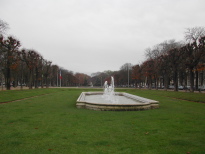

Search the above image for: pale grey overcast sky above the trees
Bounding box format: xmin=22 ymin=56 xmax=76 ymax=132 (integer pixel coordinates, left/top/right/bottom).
xmin=0 ymin=0 xmax=205 ymax=74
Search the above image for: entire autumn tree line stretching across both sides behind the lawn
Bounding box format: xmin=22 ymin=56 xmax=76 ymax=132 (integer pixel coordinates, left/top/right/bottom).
xmin=0 ymin=20 xmax=205 ymax=92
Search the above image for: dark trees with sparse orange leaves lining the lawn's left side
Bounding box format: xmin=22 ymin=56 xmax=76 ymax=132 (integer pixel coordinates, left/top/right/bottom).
xmin=0 ymin=20 xmax=89 ymax=90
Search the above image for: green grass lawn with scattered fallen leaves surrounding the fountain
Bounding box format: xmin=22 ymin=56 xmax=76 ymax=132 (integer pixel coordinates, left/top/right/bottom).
xmin=0 ymin=88 xmax=205 ymax=154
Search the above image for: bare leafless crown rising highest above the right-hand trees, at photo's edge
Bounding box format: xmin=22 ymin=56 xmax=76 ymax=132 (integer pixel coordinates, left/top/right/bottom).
xmin=184 ymin=27 xmax=205 ymax=43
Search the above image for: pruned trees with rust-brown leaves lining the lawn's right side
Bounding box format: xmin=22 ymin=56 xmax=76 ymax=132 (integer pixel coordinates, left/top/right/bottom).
xmin=132 ymin=37 xmax=205 ymax=92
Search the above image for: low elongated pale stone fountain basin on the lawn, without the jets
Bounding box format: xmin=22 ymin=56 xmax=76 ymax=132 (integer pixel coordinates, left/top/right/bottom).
xmin=76 ymin=92 xmax=159 ymax=111
